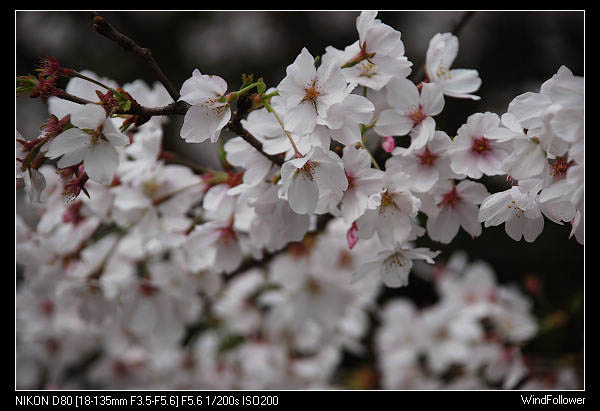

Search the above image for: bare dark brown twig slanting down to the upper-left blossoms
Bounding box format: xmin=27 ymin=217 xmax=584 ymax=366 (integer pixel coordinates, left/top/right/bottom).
xmin=92 ymin=12 xmax=180 ymax=101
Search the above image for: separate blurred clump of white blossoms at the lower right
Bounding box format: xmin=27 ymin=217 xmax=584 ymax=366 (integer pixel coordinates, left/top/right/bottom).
xmin=376 ymin=252 xmax=578 ymax=389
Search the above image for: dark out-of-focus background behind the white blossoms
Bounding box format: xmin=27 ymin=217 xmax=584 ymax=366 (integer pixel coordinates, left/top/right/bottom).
xmin=16 ymin=11 xmax=584 ymax=388
